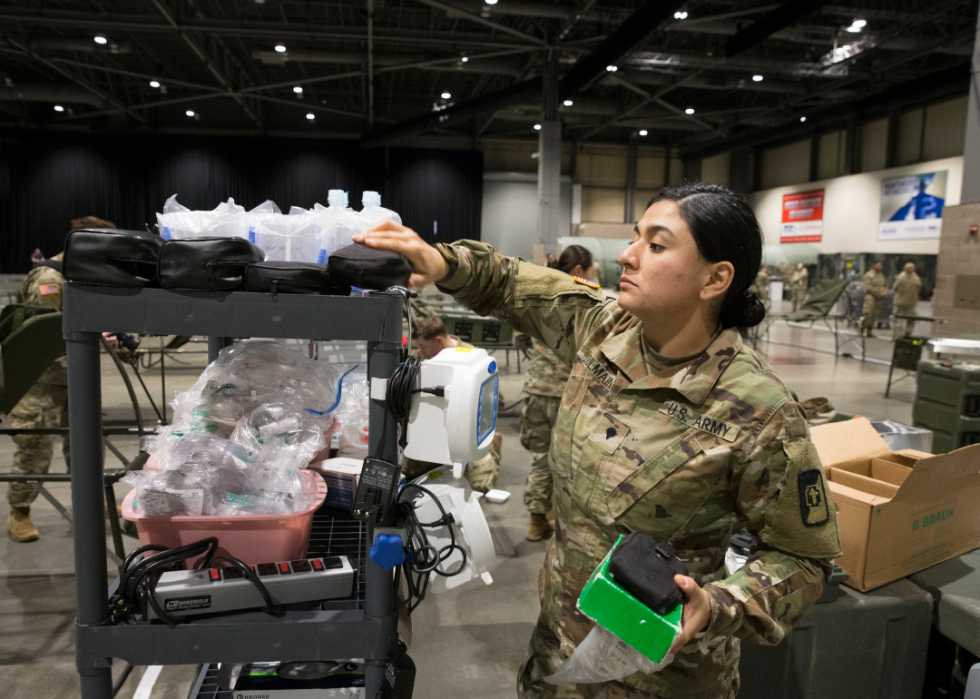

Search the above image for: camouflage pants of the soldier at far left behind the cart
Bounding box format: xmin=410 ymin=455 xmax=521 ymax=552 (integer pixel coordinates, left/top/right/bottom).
xmin=7 ymin=383 xmax=70 ymax=507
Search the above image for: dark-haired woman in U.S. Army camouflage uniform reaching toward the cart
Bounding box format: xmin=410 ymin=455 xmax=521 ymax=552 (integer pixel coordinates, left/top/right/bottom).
xmin=355 ymin=183 xmax=840 ymax=699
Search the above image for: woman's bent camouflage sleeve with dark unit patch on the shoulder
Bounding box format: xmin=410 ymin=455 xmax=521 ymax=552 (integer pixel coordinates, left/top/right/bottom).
xmin=704 ymin=402 xmax=840 ymax=644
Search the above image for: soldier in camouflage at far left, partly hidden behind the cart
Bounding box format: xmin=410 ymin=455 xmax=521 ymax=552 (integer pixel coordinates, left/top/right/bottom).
xmin=7 ymin=216 xmax=115 ymax=543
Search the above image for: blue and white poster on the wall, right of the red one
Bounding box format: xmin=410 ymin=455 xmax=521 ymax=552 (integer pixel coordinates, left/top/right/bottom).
xmin=878 ymin=170 xmax=948 ymax=240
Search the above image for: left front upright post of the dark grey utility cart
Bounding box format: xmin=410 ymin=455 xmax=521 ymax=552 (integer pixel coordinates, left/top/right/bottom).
xmin=65 ymin=333 xmax=112 ymax=699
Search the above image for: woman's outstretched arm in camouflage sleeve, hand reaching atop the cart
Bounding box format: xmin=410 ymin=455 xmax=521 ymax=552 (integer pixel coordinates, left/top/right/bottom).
xmin=354 ymin=221 xmax=612 ymax=363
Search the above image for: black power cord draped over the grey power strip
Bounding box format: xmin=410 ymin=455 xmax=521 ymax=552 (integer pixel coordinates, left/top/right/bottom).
xmin=109 ymin=536 xmax=281 ymax=627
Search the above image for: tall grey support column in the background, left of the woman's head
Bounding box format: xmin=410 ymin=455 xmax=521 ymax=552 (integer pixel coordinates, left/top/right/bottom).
xmin=538 ymin=50 xmax=568 ymax=253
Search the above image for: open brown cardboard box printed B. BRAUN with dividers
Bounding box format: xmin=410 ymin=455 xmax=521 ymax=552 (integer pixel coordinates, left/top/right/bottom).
xmin=810 ymin=418 xmax=980 ymax=592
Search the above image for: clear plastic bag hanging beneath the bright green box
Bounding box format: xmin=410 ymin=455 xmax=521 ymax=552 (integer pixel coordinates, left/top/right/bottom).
xmin=544 ymin=624 xmax=674 ymax=684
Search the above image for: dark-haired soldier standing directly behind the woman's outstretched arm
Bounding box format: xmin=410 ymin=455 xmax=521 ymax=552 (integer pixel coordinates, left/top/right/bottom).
xmin=521 ymin=245 xmax=595 ymax=541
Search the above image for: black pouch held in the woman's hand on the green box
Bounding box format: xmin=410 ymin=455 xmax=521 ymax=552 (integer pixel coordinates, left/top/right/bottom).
xmin=609 ymin=532 xmax=688 ymax=616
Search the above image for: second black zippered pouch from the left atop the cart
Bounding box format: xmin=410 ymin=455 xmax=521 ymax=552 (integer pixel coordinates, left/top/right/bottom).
xmin=157 ymin=238 xmax=265 ymax=291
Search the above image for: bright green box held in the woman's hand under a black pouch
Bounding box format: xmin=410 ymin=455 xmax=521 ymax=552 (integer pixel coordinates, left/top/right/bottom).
xmin=578 ymin=536 xmax=684 ymax=663
